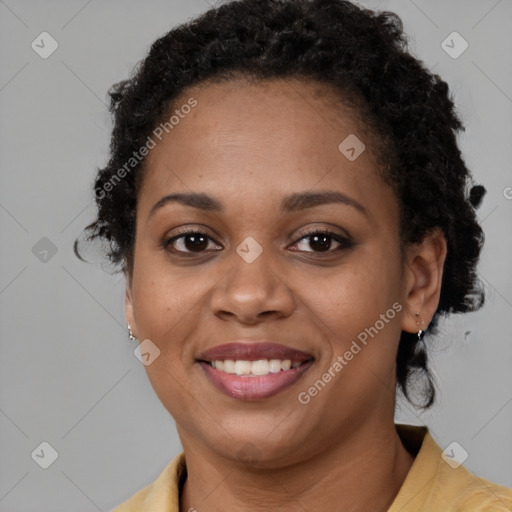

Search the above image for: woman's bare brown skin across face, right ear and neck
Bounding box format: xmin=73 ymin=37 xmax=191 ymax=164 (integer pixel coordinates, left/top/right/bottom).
xmin=126 ymin=79 xmax=446 ymax=512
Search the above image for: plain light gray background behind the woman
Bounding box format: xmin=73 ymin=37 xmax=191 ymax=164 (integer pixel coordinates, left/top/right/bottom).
xmin=0 ymin=0 xmax=512 ymax=512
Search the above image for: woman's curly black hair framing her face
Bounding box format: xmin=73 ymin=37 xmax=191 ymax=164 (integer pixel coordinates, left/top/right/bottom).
xmin=75 ymin=0 xmax=485 ymax=408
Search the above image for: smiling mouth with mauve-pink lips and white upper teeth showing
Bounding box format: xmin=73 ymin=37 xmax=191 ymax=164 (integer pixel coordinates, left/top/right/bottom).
xmin=196 ymin=341 xmax=314 ymax=400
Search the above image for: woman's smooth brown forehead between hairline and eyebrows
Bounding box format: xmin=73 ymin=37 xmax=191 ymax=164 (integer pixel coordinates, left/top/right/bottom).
xmin=135 ymin=79 xmax=392 ymax=222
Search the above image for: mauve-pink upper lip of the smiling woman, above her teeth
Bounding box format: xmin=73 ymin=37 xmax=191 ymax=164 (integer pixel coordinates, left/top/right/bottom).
xmin=197 ymin=340 xmax=313 ymax=363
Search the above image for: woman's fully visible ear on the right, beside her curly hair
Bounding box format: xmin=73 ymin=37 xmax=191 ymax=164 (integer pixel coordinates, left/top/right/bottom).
xmin=402 ymin=228 xmax=447 ymax=333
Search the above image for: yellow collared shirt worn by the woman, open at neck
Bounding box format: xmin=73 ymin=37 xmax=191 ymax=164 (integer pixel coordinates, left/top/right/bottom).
xmin=112 ymin=425 xmax=512 ymax=512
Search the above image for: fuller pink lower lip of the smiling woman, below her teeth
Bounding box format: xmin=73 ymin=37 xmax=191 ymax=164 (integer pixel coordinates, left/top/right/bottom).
xmin=199 ymin=360 xmax=313 ymax=400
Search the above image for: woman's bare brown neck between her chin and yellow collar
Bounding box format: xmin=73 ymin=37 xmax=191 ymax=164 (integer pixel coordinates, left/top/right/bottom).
xmin=180 ymin=423 xmax=414 ymax=512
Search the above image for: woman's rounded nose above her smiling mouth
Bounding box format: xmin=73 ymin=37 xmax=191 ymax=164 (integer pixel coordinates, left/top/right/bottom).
xmin=211 ymin=253 xmax=296 ymax=325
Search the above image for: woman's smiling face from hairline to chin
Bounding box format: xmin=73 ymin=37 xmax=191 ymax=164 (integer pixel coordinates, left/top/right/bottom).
xmin=126 ymin=79 xmax=440 ymax=465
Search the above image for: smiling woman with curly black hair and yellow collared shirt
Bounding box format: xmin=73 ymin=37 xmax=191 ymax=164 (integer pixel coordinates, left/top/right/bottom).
xmin=77 ymin=0 xmax=512 ymax=512
